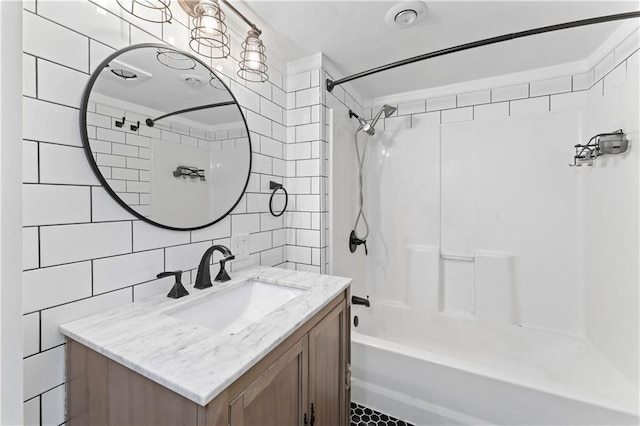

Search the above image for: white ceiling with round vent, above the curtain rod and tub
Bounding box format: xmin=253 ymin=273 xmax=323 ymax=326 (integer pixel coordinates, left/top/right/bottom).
xmin=242 ymin=0 xmax=640 ymax=99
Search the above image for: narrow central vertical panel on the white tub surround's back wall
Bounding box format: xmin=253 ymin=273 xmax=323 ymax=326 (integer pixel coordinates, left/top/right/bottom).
xmin=442 ymin=123 xmax=481 ymax=257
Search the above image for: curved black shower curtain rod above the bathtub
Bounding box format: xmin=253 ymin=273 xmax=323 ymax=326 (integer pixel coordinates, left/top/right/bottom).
xmin=326 ymin=12 xmax=640 ymax=92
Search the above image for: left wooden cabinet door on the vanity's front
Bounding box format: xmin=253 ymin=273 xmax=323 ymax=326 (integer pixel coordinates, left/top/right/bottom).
xmin=229 ymin=336 xmax=308 ymax=426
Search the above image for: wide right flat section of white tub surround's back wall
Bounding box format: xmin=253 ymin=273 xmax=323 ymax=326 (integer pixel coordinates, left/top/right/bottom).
xmin=474 ymin=110 xmax=584 ymax=334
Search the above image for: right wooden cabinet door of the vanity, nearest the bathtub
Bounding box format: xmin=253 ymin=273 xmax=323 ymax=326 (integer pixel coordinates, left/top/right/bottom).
xmin=309 ymin=302 xmax=348 ymax=426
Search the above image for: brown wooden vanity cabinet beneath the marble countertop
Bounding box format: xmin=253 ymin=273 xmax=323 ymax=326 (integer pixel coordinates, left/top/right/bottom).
xmin=67 ymin=289 xmax=350 ymax=426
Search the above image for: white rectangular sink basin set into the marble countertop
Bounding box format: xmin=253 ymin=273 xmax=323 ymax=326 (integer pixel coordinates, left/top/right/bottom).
xmin=166 ymin=279 xmax=305 ymax=334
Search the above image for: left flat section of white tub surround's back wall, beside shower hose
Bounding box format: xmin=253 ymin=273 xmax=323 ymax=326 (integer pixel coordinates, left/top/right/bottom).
xmin=364 ymin=127 xmax=440 ymax=304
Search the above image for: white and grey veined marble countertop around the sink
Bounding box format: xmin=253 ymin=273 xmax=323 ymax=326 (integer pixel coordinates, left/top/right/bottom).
xmin=60 ymin=265 xmax=351 ymax=406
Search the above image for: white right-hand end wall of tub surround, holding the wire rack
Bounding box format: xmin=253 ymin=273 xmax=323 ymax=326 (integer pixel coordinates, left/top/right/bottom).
xmin=578 ymin=51 xmax=640 ymax=387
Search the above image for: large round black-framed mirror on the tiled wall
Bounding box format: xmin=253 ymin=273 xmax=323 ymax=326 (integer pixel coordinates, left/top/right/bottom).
xmin=80 ymin=44 xmax=252 ymax=230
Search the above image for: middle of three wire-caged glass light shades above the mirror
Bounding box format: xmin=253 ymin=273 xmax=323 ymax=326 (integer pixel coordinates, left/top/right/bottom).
xmin=189 ymin=0 xmax=231 ymax=58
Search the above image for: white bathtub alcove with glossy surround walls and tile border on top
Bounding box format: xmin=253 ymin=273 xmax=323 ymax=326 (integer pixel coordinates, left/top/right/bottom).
xmin=327 ymin=23 xmax=640 ymax=425
